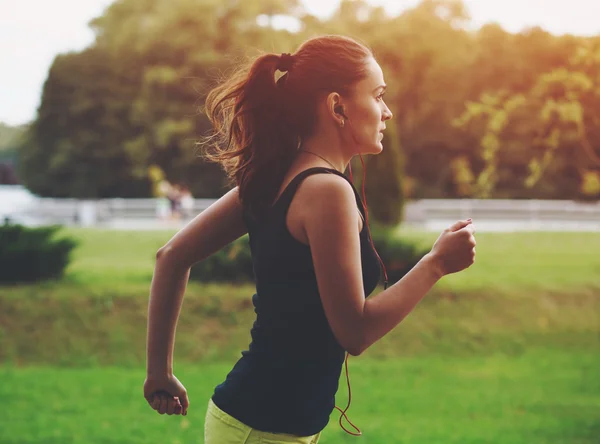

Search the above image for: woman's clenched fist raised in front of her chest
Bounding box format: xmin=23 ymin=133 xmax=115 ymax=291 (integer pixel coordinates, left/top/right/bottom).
xmin=430 ymin=219 xmax=476 ymax=276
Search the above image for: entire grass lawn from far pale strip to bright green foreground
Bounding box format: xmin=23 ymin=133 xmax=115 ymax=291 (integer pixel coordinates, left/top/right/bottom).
xmin=0 ymin=230 xmax=600 ymax=444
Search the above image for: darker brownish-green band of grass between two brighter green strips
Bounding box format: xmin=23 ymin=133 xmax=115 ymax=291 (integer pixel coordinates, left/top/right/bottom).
xmin=0 ymin=278 xmax=600 ymax=367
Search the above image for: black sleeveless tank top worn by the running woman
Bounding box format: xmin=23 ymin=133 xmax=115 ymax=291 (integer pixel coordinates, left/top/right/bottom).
xmin=212 ymin=168 xmax=381 ymax=436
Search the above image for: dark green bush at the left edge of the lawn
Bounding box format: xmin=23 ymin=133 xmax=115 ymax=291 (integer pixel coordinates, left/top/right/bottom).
xmin=0 ymin=223 xmax=77 ymax=284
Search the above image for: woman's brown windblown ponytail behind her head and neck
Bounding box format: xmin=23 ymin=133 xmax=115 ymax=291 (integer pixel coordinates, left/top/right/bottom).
xmin=205 ymin=54 xmax=299 ymax=214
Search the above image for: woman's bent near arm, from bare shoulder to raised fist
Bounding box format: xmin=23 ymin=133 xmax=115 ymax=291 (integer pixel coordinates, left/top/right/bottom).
xmin=299 ymin=176 xmax=474 ymax=355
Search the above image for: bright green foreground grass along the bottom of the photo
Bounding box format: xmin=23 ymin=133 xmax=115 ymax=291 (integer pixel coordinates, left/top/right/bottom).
xmin=0 ymin=349 xmax=600 ymax=444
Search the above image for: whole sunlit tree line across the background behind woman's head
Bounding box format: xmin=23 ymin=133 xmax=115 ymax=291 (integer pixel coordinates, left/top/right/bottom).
xmin=4 ymin=0 xmax=600 ymax=215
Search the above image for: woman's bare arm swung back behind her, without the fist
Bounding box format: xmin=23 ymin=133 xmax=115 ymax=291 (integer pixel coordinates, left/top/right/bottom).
xmin=146 ymin=188 xmax=247 ymax=376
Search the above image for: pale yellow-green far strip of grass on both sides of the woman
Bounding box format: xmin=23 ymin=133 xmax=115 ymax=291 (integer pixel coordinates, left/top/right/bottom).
xmin=52 ymin=229 xmax=600 ymax=292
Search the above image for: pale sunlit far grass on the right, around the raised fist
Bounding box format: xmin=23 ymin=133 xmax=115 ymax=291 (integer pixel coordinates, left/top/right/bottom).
xmin=398 ymin=230 xmax=600 ymax=292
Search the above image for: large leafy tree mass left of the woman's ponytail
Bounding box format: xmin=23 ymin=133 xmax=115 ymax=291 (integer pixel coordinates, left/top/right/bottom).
xmin=21 ymin=0 xmax=310 ymax=198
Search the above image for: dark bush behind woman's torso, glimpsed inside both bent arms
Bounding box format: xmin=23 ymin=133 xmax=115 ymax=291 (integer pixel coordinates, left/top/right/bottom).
xmin=190 ymin=228 xmax=426 ymax=285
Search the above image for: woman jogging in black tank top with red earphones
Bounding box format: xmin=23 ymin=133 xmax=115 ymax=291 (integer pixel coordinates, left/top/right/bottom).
xmin=144 ymin=36 xmax=475 ymax=444
